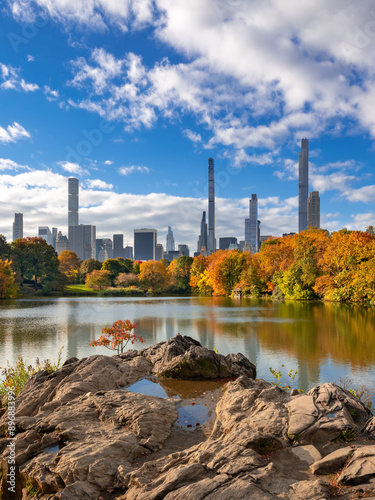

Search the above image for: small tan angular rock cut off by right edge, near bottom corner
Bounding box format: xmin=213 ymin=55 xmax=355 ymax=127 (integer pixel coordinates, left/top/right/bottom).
xmin=337 ymin=445 xmax=375 ymax=485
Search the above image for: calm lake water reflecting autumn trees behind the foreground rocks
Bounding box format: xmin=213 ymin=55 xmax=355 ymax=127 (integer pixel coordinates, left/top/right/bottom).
xmin=0 ymin=297 xmax=375 ymax=390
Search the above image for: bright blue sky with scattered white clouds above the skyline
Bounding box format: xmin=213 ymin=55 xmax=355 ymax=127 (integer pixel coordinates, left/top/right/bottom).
xmin=0 ymin=0 xmax=375 ymax=252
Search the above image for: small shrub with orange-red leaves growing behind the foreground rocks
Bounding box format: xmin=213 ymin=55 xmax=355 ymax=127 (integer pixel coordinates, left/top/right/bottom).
xmin=89 ymin=319 xmax=144 ymax=354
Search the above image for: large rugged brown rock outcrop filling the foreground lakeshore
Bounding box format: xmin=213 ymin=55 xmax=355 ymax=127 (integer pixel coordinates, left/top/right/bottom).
xmin=0 ymin=335 xmax=375 ymax=500
